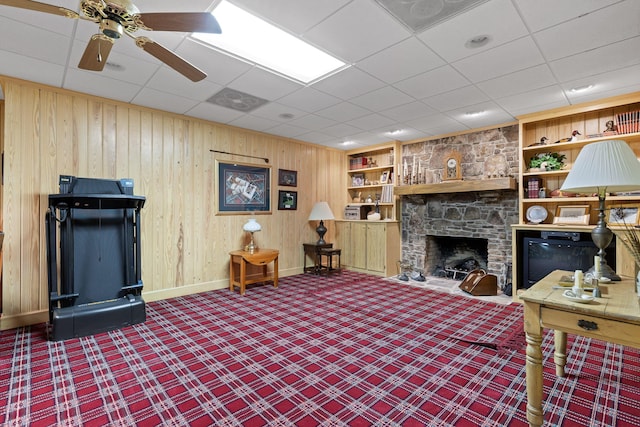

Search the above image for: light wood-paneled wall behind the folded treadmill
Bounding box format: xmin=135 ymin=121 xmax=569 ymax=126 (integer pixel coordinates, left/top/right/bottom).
xmin=0 ymin=78 xmax=347 ymax=329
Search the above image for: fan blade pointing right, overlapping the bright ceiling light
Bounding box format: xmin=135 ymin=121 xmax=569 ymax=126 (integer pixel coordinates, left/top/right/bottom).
xmin=135 ymin=12 xmax=222 ymax=34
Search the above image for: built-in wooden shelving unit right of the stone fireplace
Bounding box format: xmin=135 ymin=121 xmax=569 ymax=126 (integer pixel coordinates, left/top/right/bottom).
xmin=513 ymin=92 xmax=640 ymax=300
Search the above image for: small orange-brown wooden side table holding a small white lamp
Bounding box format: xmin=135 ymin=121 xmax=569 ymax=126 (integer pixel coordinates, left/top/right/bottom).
xmin=229 ymin=249 xmax=280 ymax=295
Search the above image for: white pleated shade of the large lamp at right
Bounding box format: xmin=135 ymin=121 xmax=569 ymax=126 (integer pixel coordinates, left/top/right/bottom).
xmin=561 ymin=140 xmax=640 ymax=194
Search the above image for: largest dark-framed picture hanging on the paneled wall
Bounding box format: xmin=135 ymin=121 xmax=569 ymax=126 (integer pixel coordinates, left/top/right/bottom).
xmin=216 ymin=160 xmax=271 ymax=215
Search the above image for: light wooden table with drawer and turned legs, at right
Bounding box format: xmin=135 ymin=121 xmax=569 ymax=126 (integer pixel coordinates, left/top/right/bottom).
xmin=520 ymin=270 xmax=640 ymax=426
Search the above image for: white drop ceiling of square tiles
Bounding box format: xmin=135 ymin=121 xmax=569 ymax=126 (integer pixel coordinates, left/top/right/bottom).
xmin=0 ymin=0 xmax=640 ymax=149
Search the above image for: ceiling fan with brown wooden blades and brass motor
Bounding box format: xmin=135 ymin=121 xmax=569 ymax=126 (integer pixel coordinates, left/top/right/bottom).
xmin=0 ymin=0 xmax=222 ymax=82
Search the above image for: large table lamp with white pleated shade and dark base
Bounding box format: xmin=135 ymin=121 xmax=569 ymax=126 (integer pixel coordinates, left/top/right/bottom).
xmin=560 ymin=140 xmax=640 ymax=280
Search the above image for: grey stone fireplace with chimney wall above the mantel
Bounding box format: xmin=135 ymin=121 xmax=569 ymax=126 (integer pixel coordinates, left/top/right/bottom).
xmin=400 ymin=125 xmax=518 ymax=287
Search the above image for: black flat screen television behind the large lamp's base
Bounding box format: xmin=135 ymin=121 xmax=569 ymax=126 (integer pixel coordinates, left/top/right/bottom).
xmin=520 ymin=233 xmax=616 ymax=288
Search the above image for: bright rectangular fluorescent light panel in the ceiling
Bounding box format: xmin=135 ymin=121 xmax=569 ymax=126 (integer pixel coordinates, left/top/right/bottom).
xmin=193 ymin=1 xmax=347 ymax=84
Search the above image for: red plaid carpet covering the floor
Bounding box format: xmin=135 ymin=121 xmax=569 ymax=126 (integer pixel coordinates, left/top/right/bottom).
xmin=0 ymin=272 xmax=640 ymax=426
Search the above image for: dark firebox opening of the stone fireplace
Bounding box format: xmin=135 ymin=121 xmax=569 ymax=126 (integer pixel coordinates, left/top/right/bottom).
xmin=424 ymin=236 xmax=489 ymax=280
